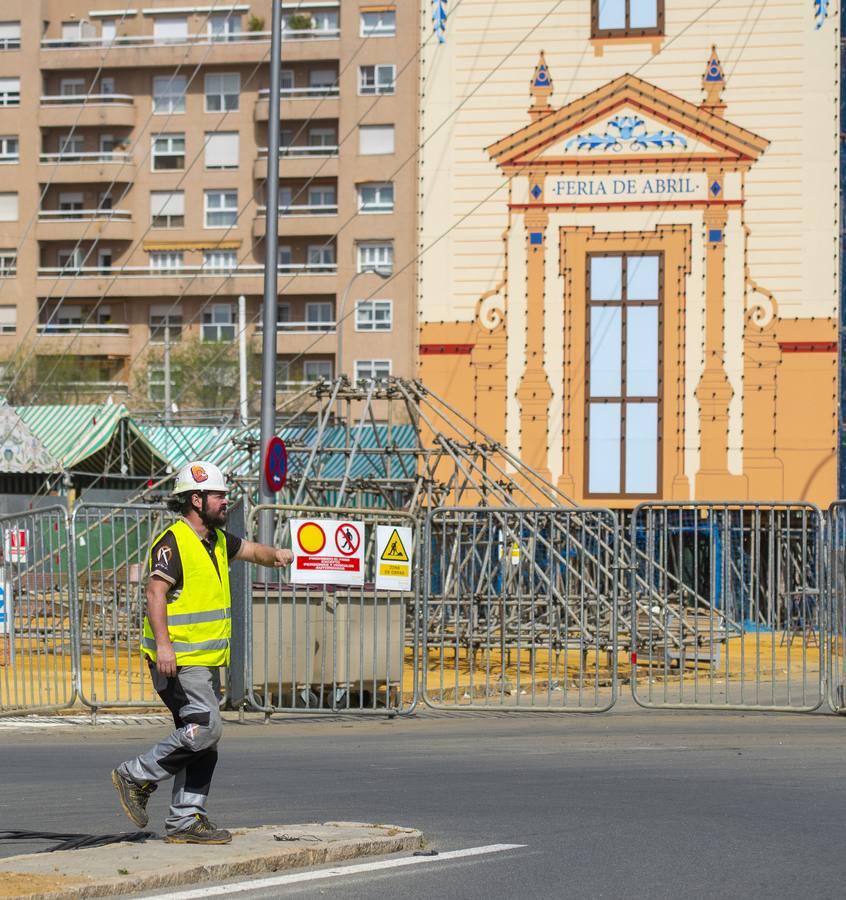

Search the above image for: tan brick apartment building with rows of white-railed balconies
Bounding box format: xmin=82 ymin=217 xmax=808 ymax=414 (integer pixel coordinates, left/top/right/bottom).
xmin=0 ymin=0 xmax=418 ymax=407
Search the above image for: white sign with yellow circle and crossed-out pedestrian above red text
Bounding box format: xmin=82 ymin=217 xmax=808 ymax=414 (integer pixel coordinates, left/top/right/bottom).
xmin=291 ymin=519 xmax=364 ymax=585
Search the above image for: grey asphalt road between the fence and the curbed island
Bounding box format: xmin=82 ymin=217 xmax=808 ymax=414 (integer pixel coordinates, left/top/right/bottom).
xmin=0 ymin=704 xmax=846 ymax=900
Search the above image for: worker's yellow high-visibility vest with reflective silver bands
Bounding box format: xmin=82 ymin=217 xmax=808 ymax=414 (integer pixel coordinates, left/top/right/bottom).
xmin=141 ymin=519 xmax=232 ymax=666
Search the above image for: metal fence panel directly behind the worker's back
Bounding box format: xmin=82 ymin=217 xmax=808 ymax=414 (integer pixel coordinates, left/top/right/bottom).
xmin=71 ymin=503 xmax=172 ymax=708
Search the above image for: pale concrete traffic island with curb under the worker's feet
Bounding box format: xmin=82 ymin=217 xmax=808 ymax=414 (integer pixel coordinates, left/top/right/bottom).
xmin=0 ymin=822 xmax=423 ymax=900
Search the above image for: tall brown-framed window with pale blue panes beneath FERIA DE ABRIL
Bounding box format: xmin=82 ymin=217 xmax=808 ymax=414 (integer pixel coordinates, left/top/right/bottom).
xmin=585 ymin=253 xmax=662 ymax=496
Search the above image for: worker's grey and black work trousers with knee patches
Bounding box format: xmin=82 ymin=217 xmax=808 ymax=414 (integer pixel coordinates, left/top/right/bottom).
xmin=118 ymin=663 xmax=223 ymax=834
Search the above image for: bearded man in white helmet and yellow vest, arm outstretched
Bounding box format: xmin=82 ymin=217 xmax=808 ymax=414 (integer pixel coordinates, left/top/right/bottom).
xmin=112 ymin=460 xmax=293 ymax=844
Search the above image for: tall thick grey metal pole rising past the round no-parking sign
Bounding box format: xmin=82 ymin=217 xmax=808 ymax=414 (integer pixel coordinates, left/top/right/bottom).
xmin=259 ymin=0 xmax=282 ymax=544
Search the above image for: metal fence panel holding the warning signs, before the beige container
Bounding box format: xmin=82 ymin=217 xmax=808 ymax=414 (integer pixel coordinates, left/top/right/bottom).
xmin=246 ymin=506 xmax=420 ymax=715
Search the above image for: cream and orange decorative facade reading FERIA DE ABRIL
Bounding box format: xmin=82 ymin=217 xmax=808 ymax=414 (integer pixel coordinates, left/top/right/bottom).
xmin=419 ymin=0 xmax=839 ymax=507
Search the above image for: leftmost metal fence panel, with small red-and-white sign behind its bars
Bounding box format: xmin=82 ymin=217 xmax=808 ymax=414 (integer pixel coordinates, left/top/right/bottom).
xmin=0 ymin=506 xmax=76 ymax=713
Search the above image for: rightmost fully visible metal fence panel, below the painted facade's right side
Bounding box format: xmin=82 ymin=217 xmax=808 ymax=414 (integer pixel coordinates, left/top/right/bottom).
xmin=629 ymin=503 xmax=825 ymax=711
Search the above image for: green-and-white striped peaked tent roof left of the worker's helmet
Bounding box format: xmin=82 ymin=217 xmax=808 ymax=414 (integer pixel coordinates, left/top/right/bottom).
xmin=16 ymin=403 xmax=167 ymax=477
